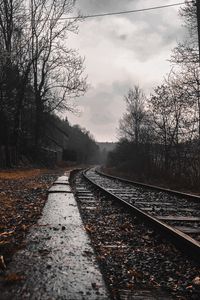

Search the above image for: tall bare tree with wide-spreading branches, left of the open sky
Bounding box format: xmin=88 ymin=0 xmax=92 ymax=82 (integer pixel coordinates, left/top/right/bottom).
xmin=30 ymin=0 xmax=86 ymax=145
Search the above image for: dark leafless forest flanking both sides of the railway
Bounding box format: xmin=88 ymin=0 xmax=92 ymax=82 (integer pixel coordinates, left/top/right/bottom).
xmin=0 ymin=0 xmax=200 ymax=187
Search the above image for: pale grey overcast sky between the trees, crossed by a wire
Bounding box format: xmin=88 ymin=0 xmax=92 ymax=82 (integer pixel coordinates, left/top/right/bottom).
xmin=67 ymin=0 xmax=184 ymax=141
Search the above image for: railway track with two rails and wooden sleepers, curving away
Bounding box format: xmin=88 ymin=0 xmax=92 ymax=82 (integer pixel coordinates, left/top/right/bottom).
xmin=81 ymin=168 xmax=200 ymax=260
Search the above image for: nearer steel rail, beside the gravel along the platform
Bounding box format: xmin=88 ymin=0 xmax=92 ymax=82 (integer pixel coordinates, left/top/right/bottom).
xmin=83 ymin=169 xmax=200 ymax=262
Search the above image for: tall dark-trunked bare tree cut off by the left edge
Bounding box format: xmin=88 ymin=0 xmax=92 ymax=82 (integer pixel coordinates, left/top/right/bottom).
xmin=0 ymin=0 xmax=30 ymax=162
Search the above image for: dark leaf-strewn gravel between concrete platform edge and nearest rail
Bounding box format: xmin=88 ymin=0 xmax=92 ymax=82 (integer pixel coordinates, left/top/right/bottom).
xmin=73 ymin=174 xmax=200 ymax=300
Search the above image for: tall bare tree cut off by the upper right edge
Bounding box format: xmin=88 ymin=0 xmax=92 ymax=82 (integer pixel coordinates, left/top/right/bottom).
xmin=171 ymin=1 xmax=200 ymax=140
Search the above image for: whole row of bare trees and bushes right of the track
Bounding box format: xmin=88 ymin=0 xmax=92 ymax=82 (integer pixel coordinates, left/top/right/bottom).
xmin=108 ymin=1 xmax=200 ymax=186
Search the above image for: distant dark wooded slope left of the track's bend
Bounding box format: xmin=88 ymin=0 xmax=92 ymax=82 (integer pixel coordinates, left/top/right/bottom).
xmin=44 ymin=114 xmax=100 ymax=164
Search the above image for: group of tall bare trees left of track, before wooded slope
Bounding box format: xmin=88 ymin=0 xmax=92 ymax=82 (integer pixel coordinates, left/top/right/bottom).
xmin=0 ymin=0 xmax=87 ymax=166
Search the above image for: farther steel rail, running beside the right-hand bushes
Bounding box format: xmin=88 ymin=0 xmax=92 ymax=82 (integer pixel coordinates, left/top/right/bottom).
xmin=95 ymin=168 xmax=200 ymax=203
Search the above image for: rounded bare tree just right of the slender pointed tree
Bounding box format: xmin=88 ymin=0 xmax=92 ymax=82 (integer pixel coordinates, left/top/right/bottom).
xmin=149 ymin=72 xmax=193 ymax=171
